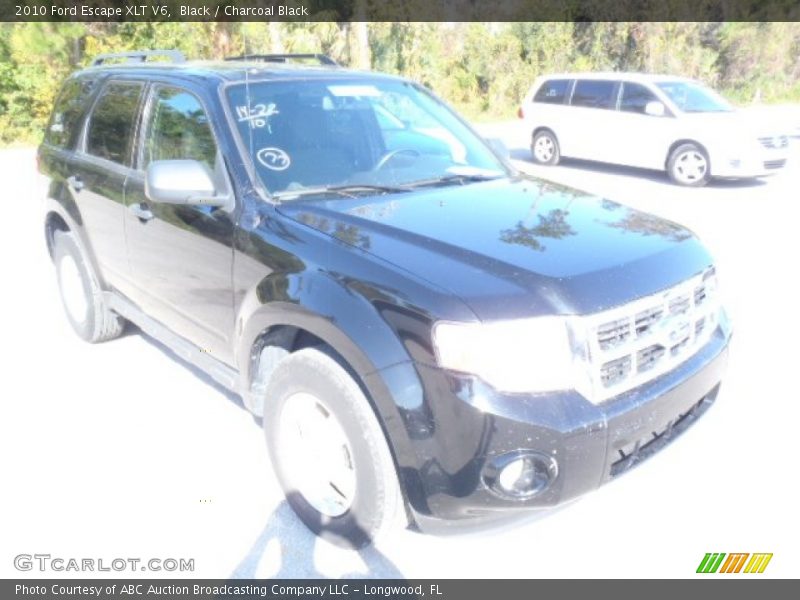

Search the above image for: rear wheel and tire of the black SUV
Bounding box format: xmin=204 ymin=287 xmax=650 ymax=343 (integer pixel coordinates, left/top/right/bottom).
xmin=53 ymin=231 xmax=125 ymax=343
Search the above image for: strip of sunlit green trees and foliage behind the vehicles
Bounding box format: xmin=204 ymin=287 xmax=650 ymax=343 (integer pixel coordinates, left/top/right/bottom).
xmin=0 ymin=22 xmax=800 ymax=144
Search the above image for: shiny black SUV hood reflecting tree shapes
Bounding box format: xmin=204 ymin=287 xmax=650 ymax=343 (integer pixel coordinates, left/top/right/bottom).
xmin=278 ymin=179 xmax=711 ymax=320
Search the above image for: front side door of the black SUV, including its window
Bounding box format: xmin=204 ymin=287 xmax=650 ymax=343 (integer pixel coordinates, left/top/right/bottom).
xmin=125 ymin=84 xmax=234 ymax=364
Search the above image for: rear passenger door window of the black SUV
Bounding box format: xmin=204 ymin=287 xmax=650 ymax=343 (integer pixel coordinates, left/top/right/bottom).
xmin=86 ymin=81 xmax=143 ymax=165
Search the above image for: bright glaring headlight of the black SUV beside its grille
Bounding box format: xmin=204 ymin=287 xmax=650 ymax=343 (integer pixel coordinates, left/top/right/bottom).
xmin=433 ymin=317 xmax=577 ymax=393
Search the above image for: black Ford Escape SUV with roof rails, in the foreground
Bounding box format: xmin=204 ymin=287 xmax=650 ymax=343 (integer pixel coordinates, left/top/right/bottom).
xmin=39 ymin=52 xmax=730 ymax=546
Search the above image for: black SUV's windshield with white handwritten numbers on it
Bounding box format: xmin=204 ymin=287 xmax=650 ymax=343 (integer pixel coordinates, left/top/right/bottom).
xmin=227 ymin=79 xmax=509 ymax=200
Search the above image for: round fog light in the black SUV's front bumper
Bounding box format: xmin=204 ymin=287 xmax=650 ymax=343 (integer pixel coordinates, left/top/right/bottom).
xmin=483 ymin=450 xmax=558 ymax=500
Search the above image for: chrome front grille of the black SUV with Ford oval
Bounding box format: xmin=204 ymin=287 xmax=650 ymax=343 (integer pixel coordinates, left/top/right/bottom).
xmin=584 ymin=267 xmax=719 ymax=402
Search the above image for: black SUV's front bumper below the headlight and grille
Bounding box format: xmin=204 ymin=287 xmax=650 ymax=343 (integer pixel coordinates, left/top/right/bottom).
xmin=368 ymin=327 xmax=729 ymax=533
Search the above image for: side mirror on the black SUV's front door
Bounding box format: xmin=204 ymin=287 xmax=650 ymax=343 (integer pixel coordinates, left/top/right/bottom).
xmin=144 ymin=160 xmax=229 ymax=206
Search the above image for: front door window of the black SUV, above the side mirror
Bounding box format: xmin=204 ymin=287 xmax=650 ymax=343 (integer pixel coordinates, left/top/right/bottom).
xmin=142 ymin=87 xmax=217 ymax=171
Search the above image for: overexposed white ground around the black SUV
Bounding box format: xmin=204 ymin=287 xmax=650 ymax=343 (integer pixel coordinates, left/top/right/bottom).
xmin=0 ymin=117 xmax=800 ymax=578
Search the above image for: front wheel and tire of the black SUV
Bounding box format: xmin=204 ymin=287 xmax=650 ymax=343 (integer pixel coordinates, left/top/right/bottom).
xmin=263 ymin=347 xmax=405 ymax=548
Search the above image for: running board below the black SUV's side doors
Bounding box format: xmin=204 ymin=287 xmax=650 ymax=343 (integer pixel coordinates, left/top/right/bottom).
xmin=103 ymin=292 xmax=244 ymax=399
